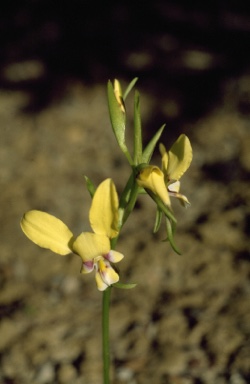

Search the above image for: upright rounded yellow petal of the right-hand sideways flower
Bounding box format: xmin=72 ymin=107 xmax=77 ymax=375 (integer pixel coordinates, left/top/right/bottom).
xmin=164 ymin=134 xmax=193 ymax=180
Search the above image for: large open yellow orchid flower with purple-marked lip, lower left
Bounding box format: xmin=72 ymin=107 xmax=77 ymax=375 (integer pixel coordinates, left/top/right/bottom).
xmin=21 ymin=179 xmax=124 ymax=291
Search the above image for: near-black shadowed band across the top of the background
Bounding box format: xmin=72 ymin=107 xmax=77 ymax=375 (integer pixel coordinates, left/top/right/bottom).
xmin=0 ymin=0 xmax=250 ymax=126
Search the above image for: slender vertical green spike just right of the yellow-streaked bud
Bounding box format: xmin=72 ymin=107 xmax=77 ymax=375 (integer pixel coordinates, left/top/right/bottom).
xmin=134 ymin=91 xmax=142 ymax=165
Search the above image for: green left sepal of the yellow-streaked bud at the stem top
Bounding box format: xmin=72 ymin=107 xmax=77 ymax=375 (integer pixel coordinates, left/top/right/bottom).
xmin=108 ymin=80 xmax=133 ymax=165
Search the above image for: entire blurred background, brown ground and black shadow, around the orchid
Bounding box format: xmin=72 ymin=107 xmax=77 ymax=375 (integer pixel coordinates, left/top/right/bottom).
xmin=0 ymin=0 xmax=250 ymax=384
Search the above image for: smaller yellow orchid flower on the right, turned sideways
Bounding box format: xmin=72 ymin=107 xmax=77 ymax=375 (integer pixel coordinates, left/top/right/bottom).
xmin=137 ymin=134 xmax=193 ymax=206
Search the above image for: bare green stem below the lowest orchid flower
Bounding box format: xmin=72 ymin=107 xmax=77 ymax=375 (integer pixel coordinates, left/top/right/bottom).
xmin=102 ymin=287 xmax=111 ymax=384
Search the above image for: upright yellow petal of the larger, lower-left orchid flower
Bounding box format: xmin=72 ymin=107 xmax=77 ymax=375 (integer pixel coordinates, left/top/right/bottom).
xmin=89 ymin=179 xmax=119 ymax=239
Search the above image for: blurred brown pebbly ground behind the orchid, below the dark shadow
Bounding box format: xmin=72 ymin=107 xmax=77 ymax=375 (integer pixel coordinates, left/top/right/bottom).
xmin=0 ymin=67 xmax=250 ymax=384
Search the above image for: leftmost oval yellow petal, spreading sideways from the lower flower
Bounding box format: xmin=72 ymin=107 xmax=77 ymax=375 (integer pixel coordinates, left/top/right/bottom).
xmin=21 ymin=210 xmax=73 ymax=255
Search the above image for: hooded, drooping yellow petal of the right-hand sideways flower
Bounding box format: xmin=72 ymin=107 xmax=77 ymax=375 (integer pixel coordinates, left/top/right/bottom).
xmin=136 ymin=165 xmax=170 ymax=206
